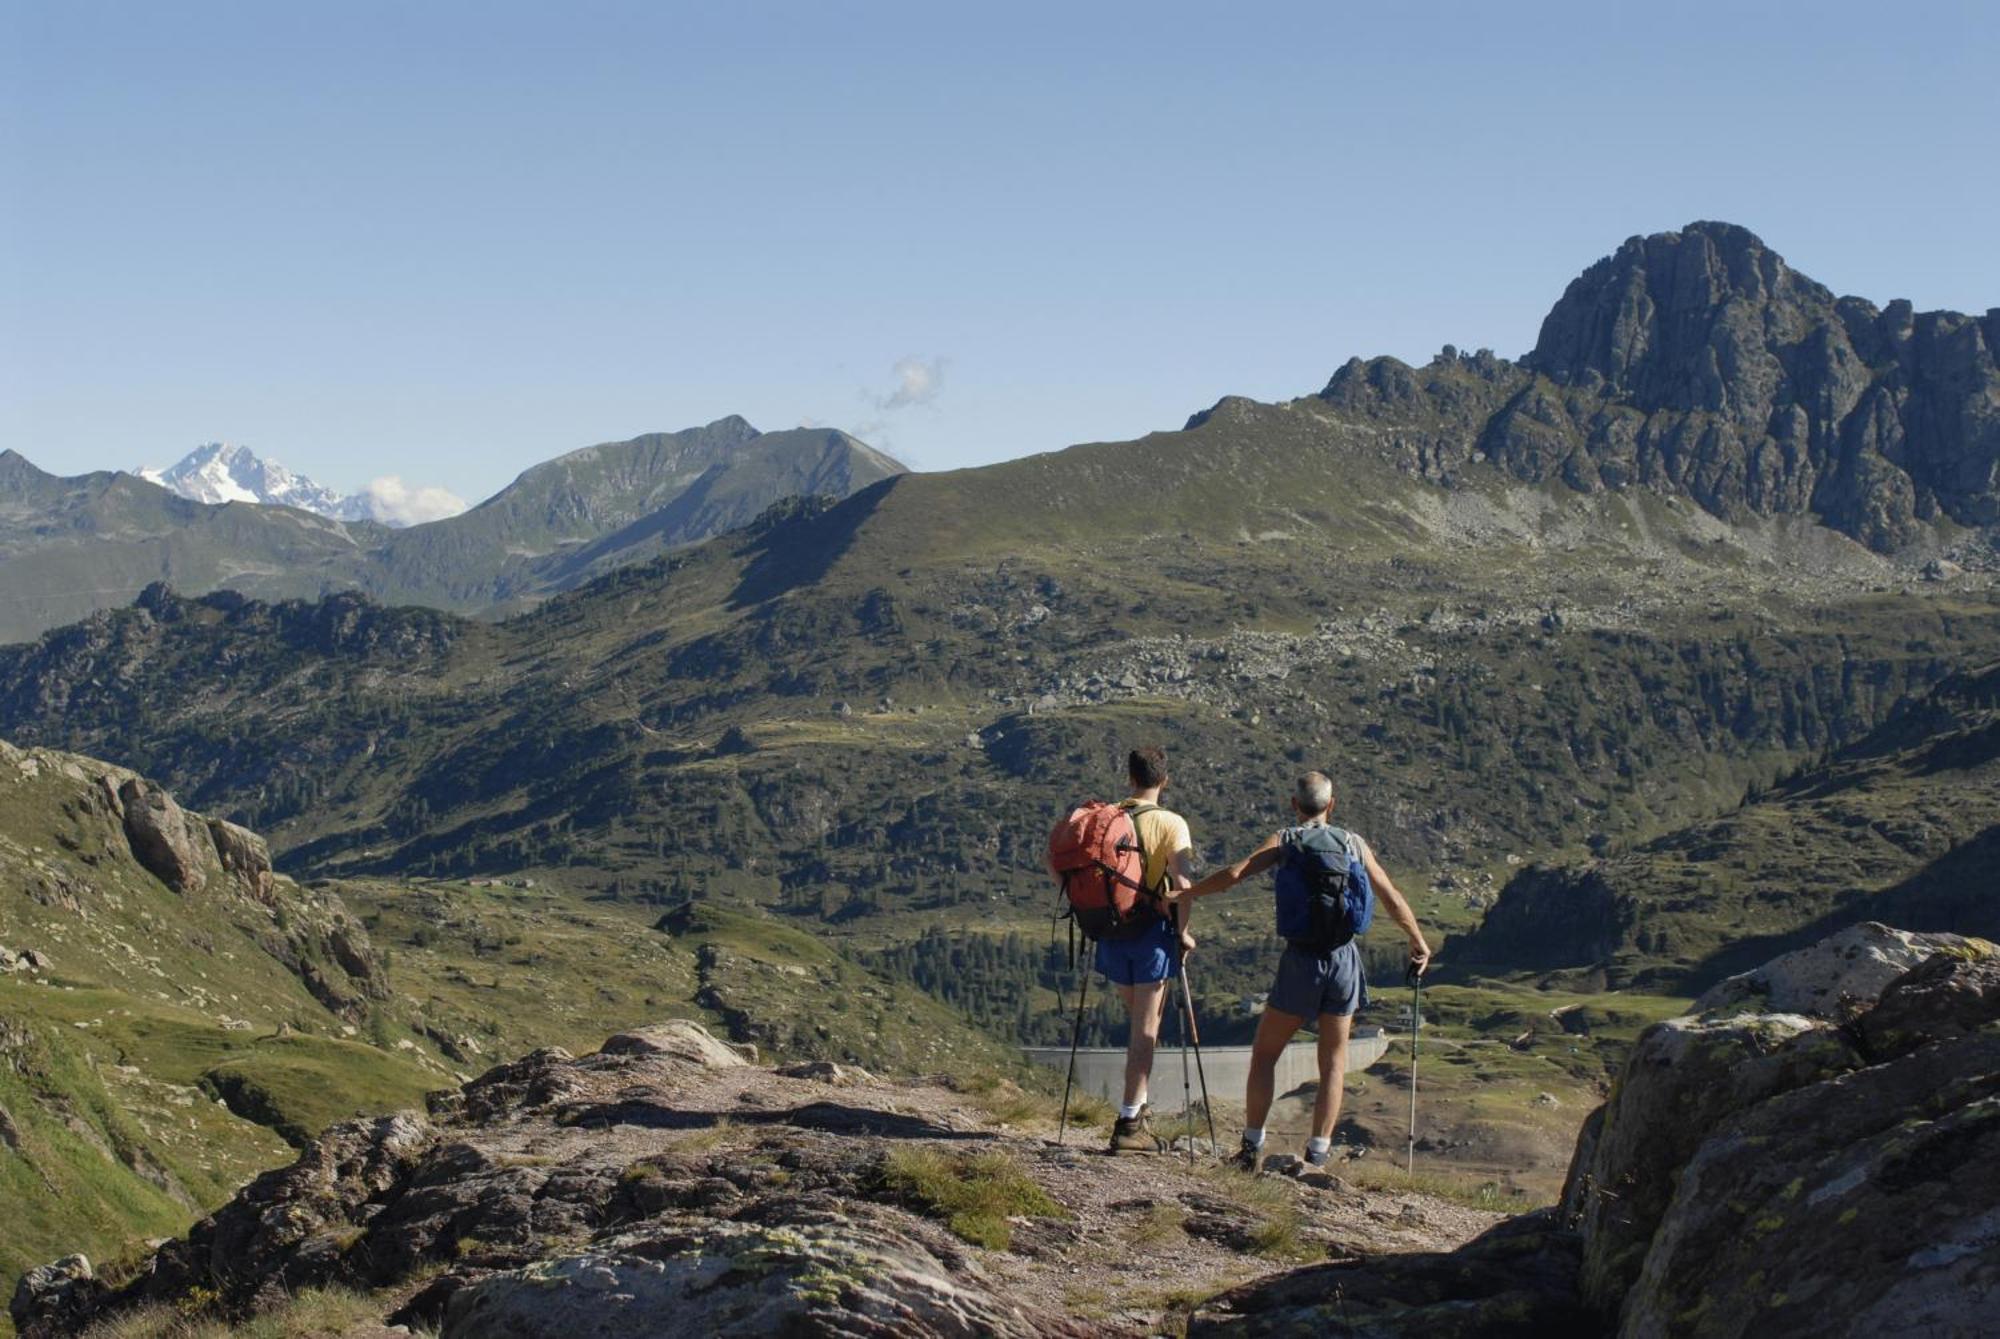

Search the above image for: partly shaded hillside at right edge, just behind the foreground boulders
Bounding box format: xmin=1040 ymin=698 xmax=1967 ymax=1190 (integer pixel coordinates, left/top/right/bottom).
xmin=1460 ymin=666 xmax=2000 ymax=989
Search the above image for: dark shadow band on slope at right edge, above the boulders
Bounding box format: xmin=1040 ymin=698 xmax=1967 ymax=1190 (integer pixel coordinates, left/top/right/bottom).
xmin=1692 ymin=825 xmax=2000 ymax=989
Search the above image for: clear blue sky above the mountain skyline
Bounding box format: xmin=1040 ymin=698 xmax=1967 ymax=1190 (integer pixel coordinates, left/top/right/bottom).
xmin=0 ymin=0 xmax=2000 ymax=498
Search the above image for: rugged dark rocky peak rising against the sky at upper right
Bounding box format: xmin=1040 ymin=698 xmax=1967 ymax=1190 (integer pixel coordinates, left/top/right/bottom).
xmin=1520 ymin=224 xmax=2000 ymax=548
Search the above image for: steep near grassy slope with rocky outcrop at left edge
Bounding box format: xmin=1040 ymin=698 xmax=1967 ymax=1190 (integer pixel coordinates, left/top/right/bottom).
xmin=0 ymin=743 xmax=448 ymax=1277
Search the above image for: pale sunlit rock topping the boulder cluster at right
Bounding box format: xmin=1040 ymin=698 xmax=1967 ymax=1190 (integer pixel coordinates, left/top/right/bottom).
xmin=1694 ymin=921 xmax=1980 ymax=1021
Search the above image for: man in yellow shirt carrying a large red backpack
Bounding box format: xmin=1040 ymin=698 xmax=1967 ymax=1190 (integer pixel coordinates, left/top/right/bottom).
xmin=1048 ymin=747 xmax=1194 ymax=1153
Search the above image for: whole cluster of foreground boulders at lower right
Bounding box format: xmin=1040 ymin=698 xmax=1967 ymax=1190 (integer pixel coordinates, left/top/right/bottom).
xmin=1564 ymin=925 xmax=2000 ymax=1339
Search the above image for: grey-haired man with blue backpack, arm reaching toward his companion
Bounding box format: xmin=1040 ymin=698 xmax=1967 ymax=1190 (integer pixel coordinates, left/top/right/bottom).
xmin=1170 ymin=771 xmax=1430 ymax=1171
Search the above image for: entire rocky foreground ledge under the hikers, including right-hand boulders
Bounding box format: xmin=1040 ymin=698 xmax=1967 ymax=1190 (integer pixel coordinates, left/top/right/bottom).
xmin=14 ymin=925 xmax=2000 ymax=1339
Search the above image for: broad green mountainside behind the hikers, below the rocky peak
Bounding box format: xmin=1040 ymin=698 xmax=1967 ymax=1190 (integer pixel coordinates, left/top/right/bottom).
xmin=0 ymin=429 xmax=2000 ymax=1039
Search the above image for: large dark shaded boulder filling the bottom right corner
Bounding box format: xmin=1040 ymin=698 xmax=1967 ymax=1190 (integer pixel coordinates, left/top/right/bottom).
xmin=1620 ymin=1033 xmax=2000 ymax=1339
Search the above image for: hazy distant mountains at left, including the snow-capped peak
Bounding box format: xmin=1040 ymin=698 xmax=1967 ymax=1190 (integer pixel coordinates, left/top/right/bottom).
xmin=0 ymin=416 xmax=902 ymax=642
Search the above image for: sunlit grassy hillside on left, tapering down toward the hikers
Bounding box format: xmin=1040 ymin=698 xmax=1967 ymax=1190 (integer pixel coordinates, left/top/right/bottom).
xmin=0 ymin=743 xmax=1018 ymax=1285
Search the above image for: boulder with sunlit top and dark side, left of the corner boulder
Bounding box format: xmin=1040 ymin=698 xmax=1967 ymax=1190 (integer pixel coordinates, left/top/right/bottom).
xmin=1564 ymin=1013 xmax=1862 ymax=1315
